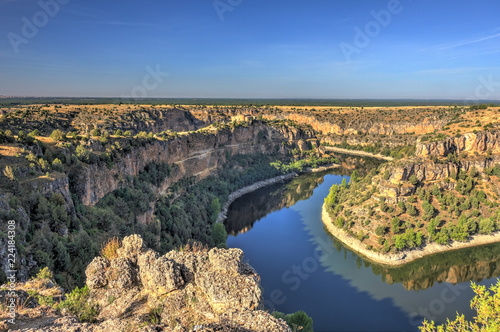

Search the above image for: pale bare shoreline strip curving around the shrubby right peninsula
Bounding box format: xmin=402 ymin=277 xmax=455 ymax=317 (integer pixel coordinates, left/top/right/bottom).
xmin=321 ymin=204 xmax=500 ymax=266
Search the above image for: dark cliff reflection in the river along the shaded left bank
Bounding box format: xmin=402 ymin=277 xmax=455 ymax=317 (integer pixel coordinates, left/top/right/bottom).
xmin=224 ymin=155 xmax=380 ymax=235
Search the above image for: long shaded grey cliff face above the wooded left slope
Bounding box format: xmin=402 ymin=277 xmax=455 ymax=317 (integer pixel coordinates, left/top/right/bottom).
xmin=74 ymin=123 xmax=310 ymax=205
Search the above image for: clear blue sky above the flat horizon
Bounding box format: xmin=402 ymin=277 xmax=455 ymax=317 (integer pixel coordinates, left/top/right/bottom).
xmin=0 ymin=0 xmax=500 ymax=100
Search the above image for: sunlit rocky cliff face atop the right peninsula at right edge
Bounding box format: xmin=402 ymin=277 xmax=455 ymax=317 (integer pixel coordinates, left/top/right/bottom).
xmin=415 ymin=131 xmax=500 ymax=158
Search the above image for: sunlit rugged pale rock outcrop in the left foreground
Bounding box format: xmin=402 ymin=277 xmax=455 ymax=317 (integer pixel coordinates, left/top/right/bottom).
xmin=0 ymin=235 xmax=291 ymax=332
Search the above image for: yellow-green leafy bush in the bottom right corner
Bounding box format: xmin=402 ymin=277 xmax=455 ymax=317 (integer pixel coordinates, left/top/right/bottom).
xmin=419 ymin=280 xmax=500 ymax=332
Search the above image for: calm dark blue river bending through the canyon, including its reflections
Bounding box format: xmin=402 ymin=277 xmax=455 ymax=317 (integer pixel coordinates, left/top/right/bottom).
xmin=225 ymin=166 xmax=500 ymax=332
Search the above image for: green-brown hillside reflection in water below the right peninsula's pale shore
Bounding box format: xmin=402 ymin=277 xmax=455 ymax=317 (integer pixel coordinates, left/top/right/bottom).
xmin=328 ymin=233 xmax=500 ymax=291
